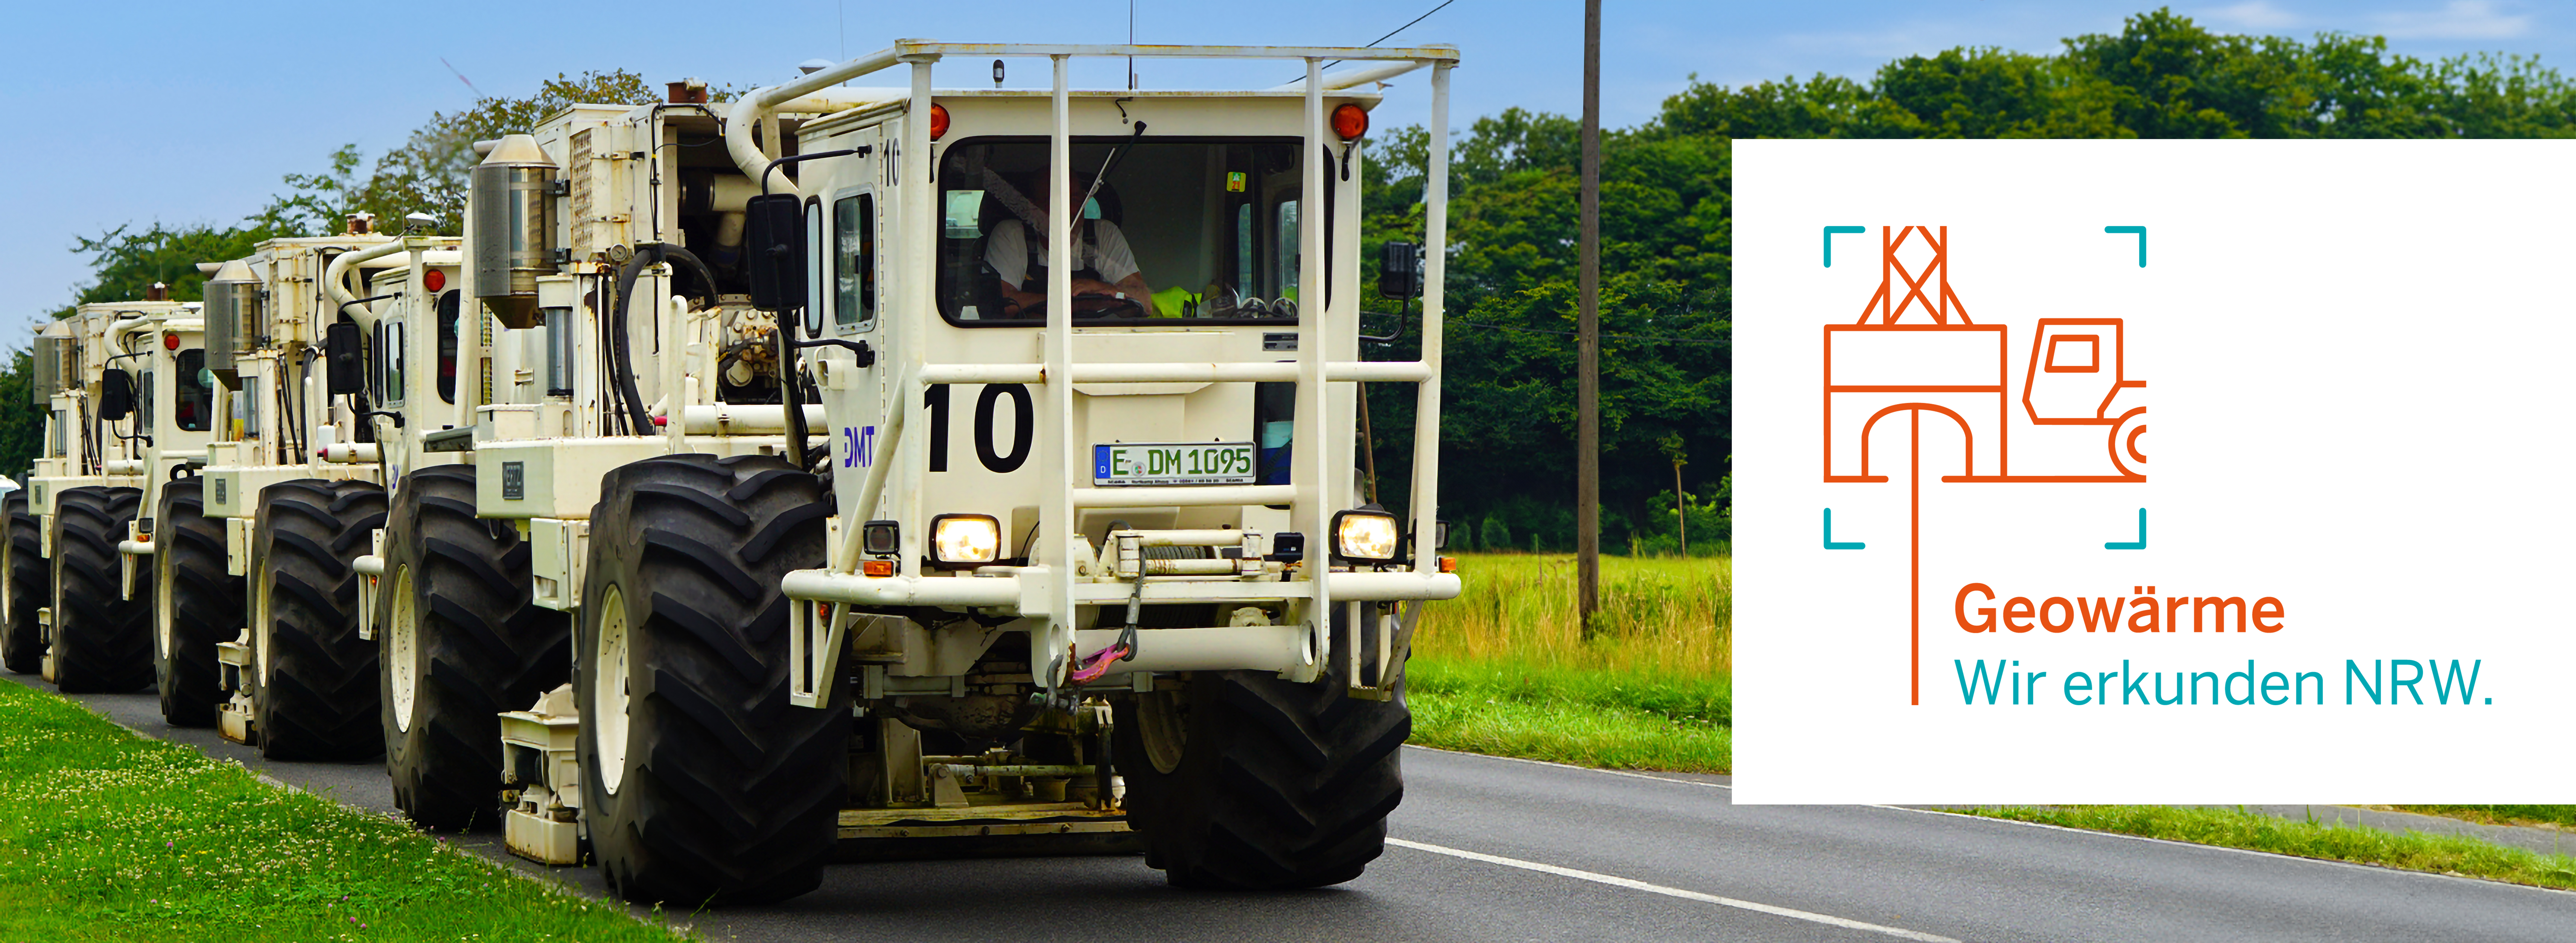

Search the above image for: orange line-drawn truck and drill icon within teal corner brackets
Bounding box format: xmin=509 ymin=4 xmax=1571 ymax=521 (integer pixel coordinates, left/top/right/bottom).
xmin=1824 ymin=227 xmax=2146 ymax=703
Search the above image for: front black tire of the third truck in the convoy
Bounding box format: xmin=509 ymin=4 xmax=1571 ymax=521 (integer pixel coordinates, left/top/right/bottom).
xmin=54 ymin=487 xmax=152 ymax=693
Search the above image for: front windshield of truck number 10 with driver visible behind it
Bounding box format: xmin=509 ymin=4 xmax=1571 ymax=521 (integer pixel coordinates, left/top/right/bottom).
xmin=938 ymin=137 xmax=1332 ymax=327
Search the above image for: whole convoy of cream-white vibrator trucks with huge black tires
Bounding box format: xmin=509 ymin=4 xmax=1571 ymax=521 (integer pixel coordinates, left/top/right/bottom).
xmin=0 ymin=41 xmax=1458 ymax=904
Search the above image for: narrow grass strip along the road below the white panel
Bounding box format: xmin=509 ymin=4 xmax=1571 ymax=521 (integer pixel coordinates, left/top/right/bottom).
xmin=1950 ymin=806 xmax=2576 ymax=889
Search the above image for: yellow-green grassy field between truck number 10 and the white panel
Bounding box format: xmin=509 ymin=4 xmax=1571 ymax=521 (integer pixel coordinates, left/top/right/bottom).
xmin=1406 ymin=554 xmax=1734 ymax=773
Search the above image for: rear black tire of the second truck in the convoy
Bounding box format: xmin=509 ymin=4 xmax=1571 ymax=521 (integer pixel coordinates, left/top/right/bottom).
xmin=152 ymin=477 xmax=247 ymax=727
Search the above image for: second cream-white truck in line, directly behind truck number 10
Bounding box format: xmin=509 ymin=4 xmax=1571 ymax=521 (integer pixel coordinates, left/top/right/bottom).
xmin=143 ymin=214 xmax=474 ymax=760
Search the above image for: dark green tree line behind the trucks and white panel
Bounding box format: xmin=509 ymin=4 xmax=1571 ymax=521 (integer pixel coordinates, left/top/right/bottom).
xmin=20 ymin=10 xmax=2576 ymax=551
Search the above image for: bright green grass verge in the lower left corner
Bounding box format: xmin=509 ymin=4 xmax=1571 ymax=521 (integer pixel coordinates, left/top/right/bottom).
xmin=0 ymin=683 xmax=675 ymax=940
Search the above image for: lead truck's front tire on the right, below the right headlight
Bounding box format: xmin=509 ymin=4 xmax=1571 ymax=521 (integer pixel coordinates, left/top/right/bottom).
xmin=1113 ymin=608 xmax=1412 ymax=891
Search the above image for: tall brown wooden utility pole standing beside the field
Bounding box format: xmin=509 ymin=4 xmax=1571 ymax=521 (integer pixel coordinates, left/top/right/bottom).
xmin=1574 ymin=0 xmax=1602 ymax=639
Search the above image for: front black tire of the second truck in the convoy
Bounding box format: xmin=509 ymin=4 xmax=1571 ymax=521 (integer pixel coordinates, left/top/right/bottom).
xmin=250 ymin=479 xmax=384 ymax=760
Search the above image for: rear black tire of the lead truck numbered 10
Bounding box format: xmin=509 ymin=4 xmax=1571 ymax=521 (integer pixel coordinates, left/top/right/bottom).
xmin=376 ymin=464 xmax=572 ymax=832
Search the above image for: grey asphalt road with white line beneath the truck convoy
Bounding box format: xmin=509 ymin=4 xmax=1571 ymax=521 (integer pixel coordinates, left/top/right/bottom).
xmin=40 ymin=680 xmax=2576 ymax=943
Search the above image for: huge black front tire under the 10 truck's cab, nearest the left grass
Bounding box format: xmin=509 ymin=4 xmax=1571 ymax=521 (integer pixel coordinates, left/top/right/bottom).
xmin=574 ymin=456 xmax=850 ymax=907
